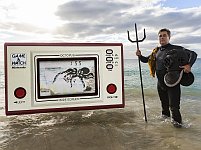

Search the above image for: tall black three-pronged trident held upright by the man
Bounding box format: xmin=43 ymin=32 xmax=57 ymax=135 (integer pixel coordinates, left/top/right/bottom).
xmin=127 ymin=23 xmax=147 ymax=122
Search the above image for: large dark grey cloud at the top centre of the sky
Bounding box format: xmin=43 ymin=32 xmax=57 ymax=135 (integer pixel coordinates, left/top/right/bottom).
xmin=55 ymin=0 xmax=131 ymax=22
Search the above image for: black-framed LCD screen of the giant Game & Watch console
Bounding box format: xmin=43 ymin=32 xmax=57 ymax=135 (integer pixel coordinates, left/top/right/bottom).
xmin=36 ymin=57 xmax=98 ymax=99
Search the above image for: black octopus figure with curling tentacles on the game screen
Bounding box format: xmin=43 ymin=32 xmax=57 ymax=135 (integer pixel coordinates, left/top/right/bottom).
xmin=53 ymin=67 xmax=94 ymax=88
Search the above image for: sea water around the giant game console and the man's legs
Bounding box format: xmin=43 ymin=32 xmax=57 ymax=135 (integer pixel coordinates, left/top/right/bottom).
xmin=0 ymin=59 xmax=201 ymax=150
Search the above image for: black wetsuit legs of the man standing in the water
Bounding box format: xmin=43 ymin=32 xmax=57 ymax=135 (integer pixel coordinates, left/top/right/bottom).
xmin=157 ymin=70 xmax=182 ymax=123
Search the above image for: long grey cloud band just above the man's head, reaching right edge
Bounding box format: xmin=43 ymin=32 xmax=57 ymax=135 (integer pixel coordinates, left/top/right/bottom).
xmin=130 ymin=8 xmax=201 ymax=29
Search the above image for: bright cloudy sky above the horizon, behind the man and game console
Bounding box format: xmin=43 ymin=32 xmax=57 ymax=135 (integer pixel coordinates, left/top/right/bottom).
xmin=0 ymin=0 xmax=201 ymax=59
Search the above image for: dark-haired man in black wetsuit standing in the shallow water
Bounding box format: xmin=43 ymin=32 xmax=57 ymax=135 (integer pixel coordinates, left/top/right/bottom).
xmin=136 ymin=28 xmax=197 ymax=127
